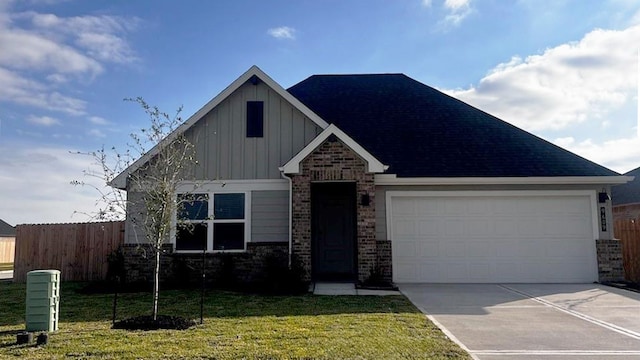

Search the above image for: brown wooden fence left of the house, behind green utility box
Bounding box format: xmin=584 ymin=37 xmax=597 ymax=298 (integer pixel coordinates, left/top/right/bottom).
xmin=13 ymin=221 xmax=124 ymax=282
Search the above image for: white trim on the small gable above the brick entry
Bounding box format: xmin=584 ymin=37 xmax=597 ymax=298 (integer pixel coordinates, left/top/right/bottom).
xmin=280 ymin=124 xmax=387 ymax=174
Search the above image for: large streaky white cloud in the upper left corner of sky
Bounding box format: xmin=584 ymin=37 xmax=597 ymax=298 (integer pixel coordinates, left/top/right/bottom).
xmin=0 ymin=1 xmax=140 ymax=115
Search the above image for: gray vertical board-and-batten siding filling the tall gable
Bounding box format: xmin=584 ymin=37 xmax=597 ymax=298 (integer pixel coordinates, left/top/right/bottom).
xmin=185 ymin=82 xmax=322 ymax=180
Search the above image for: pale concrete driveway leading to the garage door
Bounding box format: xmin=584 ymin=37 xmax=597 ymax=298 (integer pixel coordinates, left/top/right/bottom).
xmin=399 ymin=284 xmax=640 ymax=360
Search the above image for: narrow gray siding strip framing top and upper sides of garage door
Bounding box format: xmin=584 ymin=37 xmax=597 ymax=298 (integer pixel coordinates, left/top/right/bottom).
xmin=376 ymin=185 xmax=613 ymax=240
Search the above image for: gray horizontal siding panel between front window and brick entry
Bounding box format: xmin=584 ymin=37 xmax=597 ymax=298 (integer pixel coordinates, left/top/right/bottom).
xmin=251 ymin=191 xmax=289 ymax=242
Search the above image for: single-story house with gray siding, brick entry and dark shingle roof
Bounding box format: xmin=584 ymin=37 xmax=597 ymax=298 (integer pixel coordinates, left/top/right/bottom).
xmin=112 ymin=66 xmax=630 ymax=283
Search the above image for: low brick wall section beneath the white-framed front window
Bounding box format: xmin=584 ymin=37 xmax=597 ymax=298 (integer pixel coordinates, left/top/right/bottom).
xmin=123 ymin=242 xmax=288 ymax=283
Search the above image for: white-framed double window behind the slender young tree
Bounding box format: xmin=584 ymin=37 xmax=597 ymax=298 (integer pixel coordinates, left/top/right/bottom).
xmin=176 ymin=192 xmax=248 ymax=251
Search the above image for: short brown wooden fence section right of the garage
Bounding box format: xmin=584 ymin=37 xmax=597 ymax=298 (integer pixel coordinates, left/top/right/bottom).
xmin=613 ymin=219 xmax=640 ymax=283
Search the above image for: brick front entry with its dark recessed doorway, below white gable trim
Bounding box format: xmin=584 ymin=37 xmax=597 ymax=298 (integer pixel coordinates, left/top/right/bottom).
xmin=290 ymin=137 xmax=378 ymax=283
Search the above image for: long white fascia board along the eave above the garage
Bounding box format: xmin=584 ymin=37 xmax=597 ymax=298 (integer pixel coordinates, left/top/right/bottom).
xmin=375 ymin=174 xmax=634 ymax=185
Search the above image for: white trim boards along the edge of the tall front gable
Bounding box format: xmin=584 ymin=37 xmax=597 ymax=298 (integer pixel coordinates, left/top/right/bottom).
xmin=109 ymin=65 xmax=329 ymax=190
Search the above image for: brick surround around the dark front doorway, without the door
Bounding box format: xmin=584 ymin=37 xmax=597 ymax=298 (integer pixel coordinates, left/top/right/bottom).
xmin=291 ymin=137 xmax=380 ymax=282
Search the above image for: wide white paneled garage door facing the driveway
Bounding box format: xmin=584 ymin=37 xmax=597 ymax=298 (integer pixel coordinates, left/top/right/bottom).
xmin=387 ymin=192 xmax=598 ymax=283
